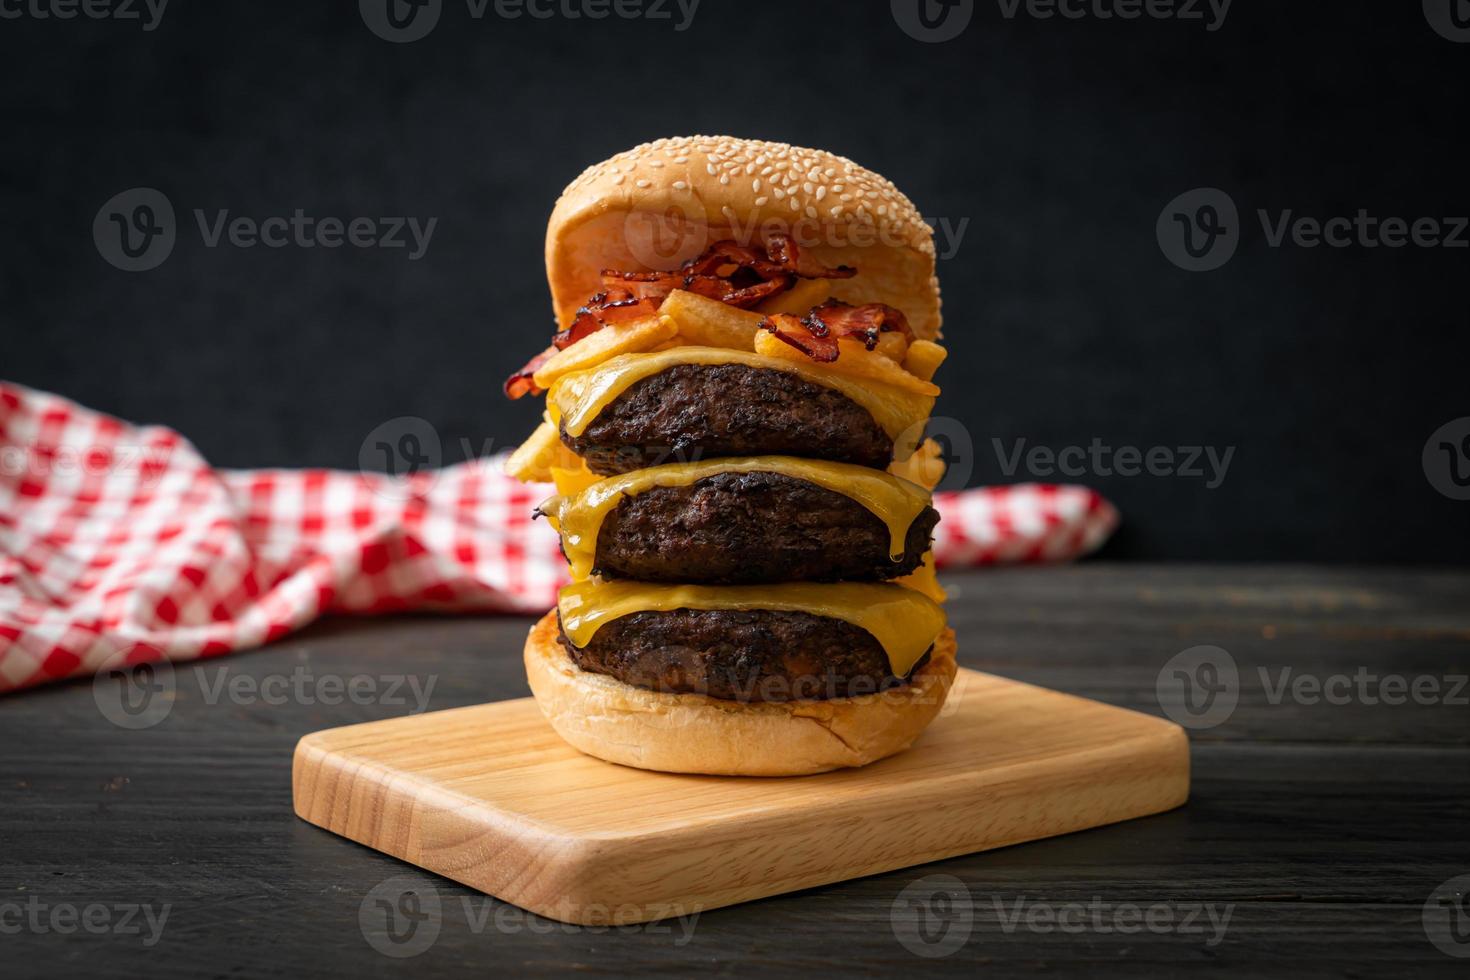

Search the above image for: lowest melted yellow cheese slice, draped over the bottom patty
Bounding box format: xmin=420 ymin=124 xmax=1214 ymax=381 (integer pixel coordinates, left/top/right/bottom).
xmin=557 ymin=580 xmax=945 ymax=677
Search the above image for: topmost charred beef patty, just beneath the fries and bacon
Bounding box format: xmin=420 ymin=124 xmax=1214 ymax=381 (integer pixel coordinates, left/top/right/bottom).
xmin=562 ymin=364 xmax=894 ymax=476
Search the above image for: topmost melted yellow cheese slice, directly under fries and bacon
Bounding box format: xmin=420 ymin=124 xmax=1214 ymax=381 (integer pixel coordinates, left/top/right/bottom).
xmin=547 ymin=347 xmax=933 ymax=460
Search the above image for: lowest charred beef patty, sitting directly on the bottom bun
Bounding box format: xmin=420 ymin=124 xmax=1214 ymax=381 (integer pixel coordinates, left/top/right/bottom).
xmin=557 ymin=610 xmax=929 ymax=701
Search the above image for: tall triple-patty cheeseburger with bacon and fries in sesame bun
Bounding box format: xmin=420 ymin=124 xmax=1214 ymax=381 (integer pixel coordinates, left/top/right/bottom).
xmin=506 ymin=137 xmax=956 ymax=776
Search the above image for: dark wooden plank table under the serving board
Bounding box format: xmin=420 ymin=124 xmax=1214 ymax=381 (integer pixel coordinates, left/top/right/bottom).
xmin=0 ymin=564 xmax=1470 ymax=977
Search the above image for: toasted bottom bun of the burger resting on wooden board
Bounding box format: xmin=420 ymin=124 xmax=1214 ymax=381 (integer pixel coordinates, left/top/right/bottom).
xmin=526 ymin=610 xmax=956 ymax=776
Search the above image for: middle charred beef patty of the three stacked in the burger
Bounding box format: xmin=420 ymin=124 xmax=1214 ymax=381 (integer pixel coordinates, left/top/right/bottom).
xmin=582 ymin=473 xmax=939 ymax=585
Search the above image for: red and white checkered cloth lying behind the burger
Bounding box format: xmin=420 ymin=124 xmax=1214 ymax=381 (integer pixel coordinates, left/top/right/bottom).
xmin=0 ymin=382 xmax=1117 ymax=691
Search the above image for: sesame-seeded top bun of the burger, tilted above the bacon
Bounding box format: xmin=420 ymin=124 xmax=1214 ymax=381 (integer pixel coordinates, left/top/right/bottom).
xmin=547 ymin=137 xmax=939 ymax=339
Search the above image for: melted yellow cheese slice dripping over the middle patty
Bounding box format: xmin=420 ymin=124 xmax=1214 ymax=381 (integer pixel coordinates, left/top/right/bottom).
xmin=539 ymin=455 xmax=929 ymax=580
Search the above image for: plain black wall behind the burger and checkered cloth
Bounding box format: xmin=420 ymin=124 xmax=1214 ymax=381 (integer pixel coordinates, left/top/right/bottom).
xmin=0 ymin=0 xmax=1470 ymax=561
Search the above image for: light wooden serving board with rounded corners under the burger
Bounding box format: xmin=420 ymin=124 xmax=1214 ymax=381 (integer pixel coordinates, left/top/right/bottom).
xmin=291 ymin=669 xmax=1189 ymax=924
